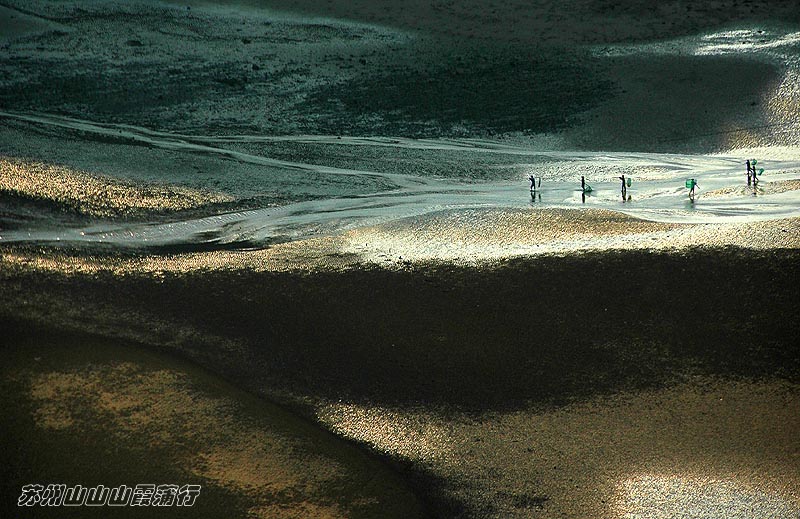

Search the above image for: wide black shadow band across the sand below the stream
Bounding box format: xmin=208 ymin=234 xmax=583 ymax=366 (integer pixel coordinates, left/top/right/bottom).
xmin=2 ymin=249 xmax=800 ymax=411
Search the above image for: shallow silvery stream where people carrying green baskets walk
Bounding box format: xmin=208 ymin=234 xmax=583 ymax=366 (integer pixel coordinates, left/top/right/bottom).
xmin=0 ymin=112 xmax=800 ymax=247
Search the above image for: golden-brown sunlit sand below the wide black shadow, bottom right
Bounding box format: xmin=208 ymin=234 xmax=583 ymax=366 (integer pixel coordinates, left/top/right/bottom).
xmin=318 ymin=378 xmax=800 ymax=519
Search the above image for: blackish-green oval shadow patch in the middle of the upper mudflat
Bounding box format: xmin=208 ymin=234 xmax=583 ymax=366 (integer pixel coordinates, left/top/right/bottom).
xmin=308 ymin=43 xmax=611 ymax=137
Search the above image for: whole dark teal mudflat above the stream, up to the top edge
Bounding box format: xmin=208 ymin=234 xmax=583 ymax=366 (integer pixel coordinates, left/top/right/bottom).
xmin=0 ymin=0 xmax=800 ymax=148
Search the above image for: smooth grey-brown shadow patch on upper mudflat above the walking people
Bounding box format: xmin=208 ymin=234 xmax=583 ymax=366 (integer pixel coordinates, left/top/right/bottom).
xmin=568 ymin=55 xmax=785 ymax=153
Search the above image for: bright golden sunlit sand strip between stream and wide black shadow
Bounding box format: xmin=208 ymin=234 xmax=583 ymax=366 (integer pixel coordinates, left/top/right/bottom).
xmin=7 ymin=209 xmax=800 ymax=275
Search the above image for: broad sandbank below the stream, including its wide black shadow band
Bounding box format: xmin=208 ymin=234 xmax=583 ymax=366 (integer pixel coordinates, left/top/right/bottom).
xmin=1 ymin=211 xmax=800 ymax=518
